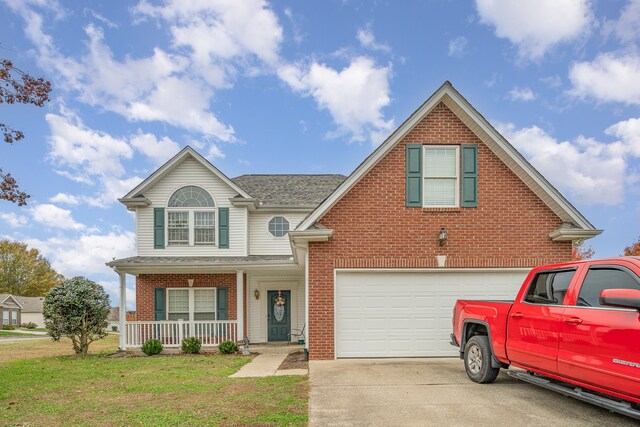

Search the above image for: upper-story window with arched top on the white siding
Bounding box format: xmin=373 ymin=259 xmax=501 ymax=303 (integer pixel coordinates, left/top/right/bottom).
xmin=167 ymin=185 xmax=216 ymax=246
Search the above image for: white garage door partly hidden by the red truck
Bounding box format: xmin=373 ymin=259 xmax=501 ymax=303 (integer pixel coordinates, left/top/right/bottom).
xmin=335 ymin=270 xmax=528 ymax=357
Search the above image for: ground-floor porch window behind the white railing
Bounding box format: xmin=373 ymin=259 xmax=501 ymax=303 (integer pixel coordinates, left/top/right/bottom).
xmin=167 ymin=288 xmax=216 ymax=321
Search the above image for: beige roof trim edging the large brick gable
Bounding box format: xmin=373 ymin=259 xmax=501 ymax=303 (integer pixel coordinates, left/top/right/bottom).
xmin=296 ymin=81 xmax=602 ymax=240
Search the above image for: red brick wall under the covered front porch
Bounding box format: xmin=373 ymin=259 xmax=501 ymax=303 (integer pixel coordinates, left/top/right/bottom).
xmin=136 ymin=273 xmax=247 ymax=335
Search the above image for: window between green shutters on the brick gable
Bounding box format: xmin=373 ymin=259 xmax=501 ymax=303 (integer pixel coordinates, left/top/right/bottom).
xmin=423 ymin=145 xmax=460 ymax=208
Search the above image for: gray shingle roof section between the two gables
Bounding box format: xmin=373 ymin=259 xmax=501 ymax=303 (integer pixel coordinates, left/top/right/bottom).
xmin=232 ymin=174 xmax=347 ymax=208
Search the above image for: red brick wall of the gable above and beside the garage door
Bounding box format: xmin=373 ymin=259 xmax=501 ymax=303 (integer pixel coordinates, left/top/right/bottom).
xmin=309 ymin=103 xmax=571 ymax=359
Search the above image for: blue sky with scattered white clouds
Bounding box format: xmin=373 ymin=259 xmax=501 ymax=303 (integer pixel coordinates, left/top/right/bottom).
xmin=0 ymin=0 xmax=640 ymax=308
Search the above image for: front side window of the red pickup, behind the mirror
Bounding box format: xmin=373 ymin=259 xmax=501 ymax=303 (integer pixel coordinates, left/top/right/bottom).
xmin=576 ymin=267 xmax=640 ymax=307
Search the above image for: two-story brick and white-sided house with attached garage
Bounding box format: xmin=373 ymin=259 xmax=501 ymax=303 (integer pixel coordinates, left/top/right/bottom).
xmin=108 ymin=82 xmax=601 ymax=359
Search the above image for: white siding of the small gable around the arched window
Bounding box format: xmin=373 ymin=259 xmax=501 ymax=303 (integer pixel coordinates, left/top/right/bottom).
xmin=136 ymin=157 xmax=248 ymax=256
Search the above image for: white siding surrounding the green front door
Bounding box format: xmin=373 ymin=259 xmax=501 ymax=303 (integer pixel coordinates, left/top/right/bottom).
xmin=245 ymin=271 xmax=308 ymax=342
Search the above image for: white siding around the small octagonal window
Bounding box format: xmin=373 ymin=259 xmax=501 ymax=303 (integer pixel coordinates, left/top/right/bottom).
xmin=249 ymin=211 xmax=310 ymax=255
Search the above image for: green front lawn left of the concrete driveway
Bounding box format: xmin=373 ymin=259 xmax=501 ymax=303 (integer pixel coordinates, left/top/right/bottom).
xmin=0 ymin=337 xmax=308 ymax=426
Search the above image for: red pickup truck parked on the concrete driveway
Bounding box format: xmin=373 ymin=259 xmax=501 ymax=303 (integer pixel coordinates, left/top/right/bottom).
xmin=451 ymin=257 xmax=640 ymax=419
